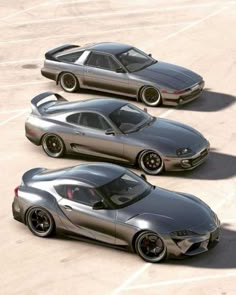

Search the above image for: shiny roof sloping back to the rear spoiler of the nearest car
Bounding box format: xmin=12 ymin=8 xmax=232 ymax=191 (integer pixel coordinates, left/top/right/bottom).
xmin=31 ymin=163 xmax=126 ymax=187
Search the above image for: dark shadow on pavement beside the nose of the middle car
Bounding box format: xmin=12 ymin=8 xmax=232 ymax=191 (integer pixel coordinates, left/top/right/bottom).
xmin=163 ymin=151 xmax=236 ymax=180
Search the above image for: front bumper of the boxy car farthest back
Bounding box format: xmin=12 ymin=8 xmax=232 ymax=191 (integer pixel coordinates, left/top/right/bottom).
xmin=162 ymin=80 xmax=205 ymax=106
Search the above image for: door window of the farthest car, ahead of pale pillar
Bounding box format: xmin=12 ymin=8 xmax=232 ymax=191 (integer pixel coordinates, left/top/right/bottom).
xmin=86 ymin=52 xmax=120 ymax=71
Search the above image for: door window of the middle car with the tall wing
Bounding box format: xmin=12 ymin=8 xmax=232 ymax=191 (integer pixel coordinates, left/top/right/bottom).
xmin=78 ymin=112 xmax=111 ymax=131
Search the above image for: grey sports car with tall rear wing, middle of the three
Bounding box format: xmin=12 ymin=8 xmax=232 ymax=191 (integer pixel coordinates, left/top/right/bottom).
xmin=25 ymin=92 xmax=209 ymax=175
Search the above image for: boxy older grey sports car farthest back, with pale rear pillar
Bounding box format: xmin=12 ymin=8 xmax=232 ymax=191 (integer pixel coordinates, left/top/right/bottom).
xmin=41 ymin=42 xmax=204 ymax=106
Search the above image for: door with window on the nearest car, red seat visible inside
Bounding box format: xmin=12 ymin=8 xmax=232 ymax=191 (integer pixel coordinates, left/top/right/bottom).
xmin=56 ymin=185 xmax=116 ymax=244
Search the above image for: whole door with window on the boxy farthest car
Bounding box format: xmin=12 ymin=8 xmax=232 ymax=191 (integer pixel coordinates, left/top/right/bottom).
xmin=84 ymin=52 xmax=130 ymax=94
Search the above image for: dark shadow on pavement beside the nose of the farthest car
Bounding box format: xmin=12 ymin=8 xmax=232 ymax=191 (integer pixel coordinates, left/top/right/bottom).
xmin=176 ymin=89 xmax=236 ymax=112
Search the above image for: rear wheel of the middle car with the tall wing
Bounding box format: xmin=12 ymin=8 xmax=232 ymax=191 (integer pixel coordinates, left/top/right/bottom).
xmin=42 ymin=133 xmax=65 ymax=158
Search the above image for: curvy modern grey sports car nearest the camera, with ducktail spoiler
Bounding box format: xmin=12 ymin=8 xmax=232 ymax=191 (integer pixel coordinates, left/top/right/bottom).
xmin=12 ymin=163 xmax=220 ymax=262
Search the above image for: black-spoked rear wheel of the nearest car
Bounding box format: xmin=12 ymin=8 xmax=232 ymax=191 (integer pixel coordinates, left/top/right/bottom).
xmin=26 ymin=207 xmax=55 ymax=238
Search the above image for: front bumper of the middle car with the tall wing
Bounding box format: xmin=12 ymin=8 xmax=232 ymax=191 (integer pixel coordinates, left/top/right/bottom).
xmin=164 ymin=145 xmax=210 ymax=171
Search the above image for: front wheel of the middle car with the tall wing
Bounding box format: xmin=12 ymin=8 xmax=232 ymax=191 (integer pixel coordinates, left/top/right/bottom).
xmin=138 ymin=150 xmax=164 ymax=175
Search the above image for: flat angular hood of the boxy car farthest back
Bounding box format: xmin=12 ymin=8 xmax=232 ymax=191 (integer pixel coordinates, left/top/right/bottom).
xmin=134 ymin=61 xmax=202 ymax=90
